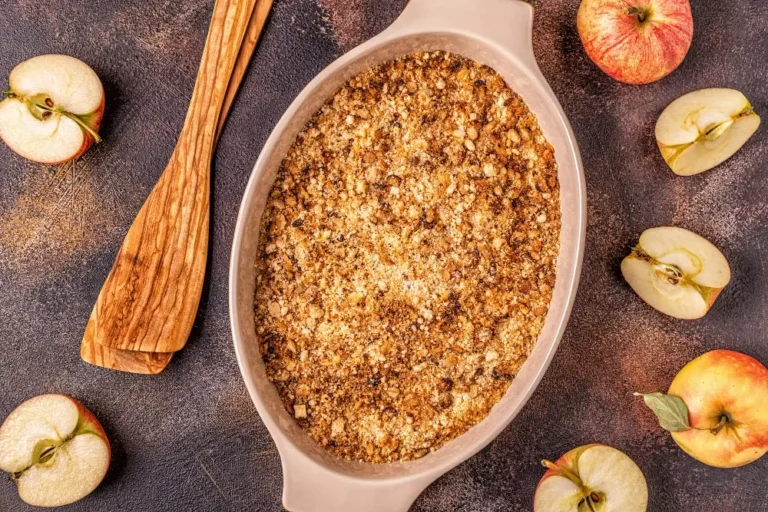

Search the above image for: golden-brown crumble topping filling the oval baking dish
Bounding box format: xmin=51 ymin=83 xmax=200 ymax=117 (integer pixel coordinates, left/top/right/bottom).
xmin=254 ymin=51 xmax=560 ymax=462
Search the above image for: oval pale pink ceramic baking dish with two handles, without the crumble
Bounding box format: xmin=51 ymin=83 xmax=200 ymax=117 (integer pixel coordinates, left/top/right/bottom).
xmin=229 ymin=0 xmax=586 ymax=512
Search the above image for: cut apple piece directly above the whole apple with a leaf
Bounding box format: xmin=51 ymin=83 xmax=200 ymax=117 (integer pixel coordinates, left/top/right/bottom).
xmin=621 ymin=227 xmax=731 ymax=320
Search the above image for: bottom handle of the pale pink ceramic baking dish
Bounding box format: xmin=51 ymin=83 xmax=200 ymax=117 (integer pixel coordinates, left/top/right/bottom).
xmin=280 ymin=447 xmax=436 ymax=512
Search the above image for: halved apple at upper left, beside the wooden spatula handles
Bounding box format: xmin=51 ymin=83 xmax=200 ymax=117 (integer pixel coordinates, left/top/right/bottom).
xmin=0 ymin=55 xmax=104 ymax=164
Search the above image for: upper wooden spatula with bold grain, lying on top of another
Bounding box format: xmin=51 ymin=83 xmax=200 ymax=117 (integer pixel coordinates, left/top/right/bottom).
xmin=83 ymin=0 xmax=256 ymax=352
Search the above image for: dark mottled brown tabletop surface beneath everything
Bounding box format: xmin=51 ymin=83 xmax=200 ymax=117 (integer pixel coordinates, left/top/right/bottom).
xmin=0 ymin=0 xmax=768 ymax=512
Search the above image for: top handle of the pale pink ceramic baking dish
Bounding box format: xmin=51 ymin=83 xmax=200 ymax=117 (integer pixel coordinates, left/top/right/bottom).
xmin=388 ymin=0 xmax=537 ymax=68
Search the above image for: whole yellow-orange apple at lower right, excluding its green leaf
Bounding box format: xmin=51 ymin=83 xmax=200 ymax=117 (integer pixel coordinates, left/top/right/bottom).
xmin=669 ymin=350 xmax=768 ymax=468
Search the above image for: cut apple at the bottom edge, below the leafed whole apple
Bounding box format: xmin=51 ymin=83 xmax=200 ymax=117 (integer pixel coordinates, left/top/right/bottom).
xmin=533 ymin=444 xmax=648 ymax=512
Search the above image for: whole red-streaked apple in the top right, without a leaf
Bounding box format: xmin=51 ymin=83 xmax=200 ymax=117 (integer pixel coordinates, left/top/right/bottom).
xmin=576 ymin=0 xmax=693 ymax=84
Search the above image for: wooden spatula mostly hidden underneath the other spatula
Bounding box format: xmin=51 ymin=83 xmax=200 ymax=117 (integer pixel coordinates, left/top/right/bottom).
xmin=80 ymin=0 xmax=272 ymax=375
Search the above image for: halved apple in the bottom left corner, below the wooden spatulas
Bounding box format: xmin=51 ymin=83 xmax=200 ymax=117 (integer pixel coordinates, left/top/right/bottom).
xmin=0 ymin=395 xmax=110 ymax=507
